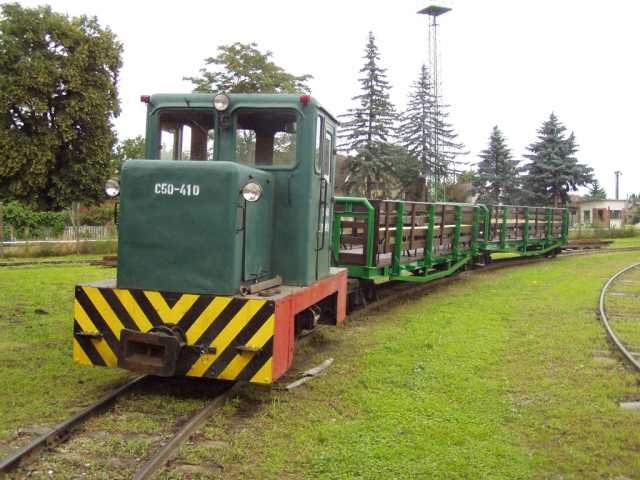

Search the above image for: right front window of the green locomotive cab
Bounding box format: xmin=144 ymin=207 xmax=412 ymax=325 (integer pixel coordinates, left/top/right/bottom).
xmin=235 ymin=110 xmax=298 ymax=167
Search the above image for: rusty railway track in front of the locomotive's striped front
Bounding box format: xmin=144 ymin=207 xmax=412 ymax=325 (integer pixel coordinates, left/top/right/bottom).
xmin=0 ymin=376 xmax=243 ymax=480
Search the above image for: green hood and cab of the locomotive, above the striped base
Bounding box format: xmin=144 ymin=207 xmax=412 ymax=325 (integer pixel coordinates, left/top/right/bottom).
xmin=118 ymin=94 xmax=336 ymax=294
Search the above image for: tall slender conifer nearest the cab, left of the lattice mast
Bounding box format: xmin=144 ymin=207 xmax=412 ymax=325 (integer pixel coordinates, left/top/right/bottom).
xmin=339 ymin=32 xmax=396 ymax=198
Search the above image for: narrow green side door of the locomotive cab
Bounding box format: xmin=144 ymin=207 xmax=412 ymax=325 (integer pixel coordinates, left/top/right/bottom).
xmin=316 ymin=115 xmax=336 ymax=279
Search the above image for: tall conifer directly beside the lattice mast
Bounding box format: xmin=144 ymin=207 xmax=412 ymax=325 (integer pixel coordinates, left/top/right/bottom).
xmin=398 ymin=65 xmax=466 ymax=201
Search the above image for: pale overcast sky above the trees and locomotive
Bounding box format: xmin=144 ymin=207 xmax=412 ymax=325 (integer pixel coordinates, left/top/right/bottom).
xmin=13 ymin=0 xmax=640 ymax=198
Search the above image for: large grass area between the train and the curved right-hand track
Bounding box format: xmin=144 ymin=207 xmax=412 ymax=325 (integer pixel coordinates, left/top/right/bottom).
xmin=165 ymin=253 xmax=640 ymax=479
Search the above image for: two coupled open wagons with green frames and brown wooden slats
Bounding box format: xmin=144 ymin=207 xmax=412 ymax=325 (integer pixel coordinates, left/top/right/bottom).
xmin=332 ymin=197 xmax=569 ymax=283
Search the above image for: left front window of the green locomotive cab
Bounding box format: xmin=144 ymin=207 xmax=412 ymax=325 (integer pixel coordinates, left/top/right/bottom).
xmin=158 ymin=109 xmax=215 ymax=160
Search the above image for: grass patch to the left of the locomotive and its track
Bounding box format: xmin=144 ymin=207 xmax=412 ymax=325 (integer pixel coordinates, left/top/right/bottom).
xmin=0 ymin=266 xmax=128 ymax=440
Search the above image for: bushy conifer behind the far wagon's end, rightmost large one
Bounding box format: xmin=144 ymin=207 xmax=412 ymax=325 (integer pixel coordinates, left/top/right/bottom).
xmin=523 ymin=113 xmax=593 ymax=207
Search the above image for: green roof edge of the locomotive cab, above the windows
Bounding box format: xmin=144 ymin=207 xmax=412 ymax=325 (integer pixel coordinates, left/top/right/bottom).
xmin=150 ymin=93 xmax=339 ymax=123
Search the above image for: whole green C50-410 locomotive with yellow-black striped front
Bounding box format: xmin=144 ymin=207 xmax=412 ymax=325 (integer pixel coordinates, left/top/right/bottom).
xmin=74 ymin=94 xmax=347 ymax=383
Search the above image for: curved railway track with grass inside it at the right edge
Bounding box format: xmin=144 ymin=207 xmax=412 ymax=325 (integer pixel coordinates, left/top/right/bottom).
xmin=599 ymin=262 xmax=640 ymax=371
